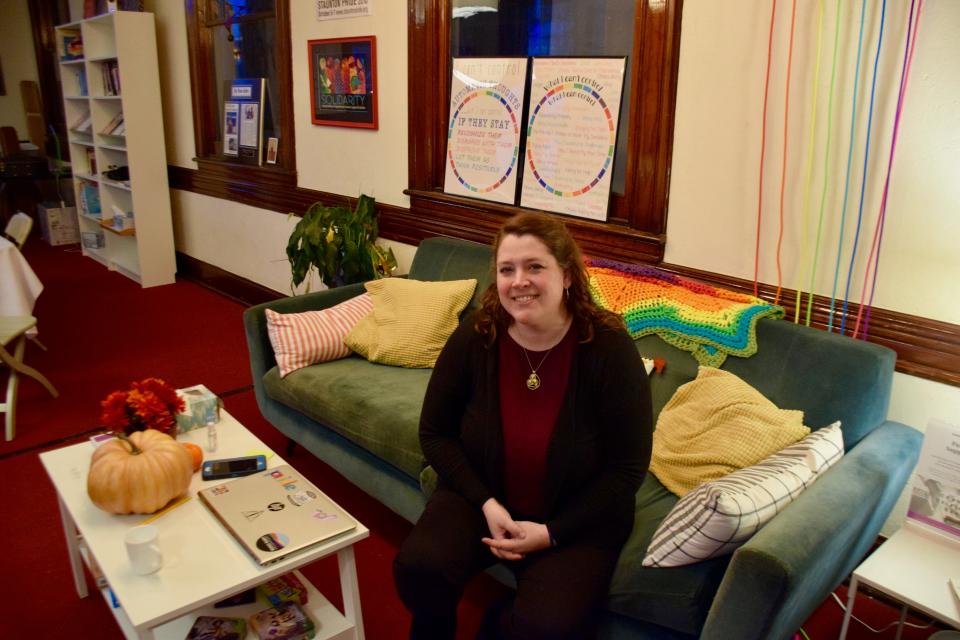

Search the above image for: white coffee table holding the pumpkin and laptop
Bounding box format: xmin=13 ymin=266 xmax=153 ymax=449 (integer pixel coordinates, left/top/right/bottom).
xmin=40 ymin=411 xmax=370 ymax=640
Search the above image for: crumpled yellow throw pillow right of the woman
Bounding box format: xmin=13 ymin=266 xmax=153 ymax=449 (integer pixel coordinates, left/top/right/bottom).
xmin=650 ymin=367 xmax=810 ymax=497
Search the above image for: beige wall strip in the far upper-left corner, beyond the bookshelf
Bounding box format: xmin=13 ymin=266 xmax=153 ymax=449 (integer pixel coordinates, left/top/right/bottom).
xmin=0 ymin=0 xmax=39 ymax=140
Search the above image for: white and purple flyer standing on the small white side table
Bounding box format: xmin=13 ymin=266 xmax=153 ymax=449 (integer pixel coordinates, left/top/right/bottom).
xmin=907 ymin=419 xmax=960 ymax=539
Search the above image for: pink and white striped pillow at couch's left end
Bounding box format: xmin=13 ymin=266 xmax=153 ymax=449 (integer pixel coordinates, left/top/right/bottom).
xmin=266 ymin=293 xmax=373 ymax=378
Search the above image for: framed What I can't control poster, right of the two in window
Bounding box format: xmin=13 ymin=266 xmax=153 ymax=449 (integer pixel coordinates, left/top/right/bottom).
xmin=520 ymin=58 xmax=626 ymax=220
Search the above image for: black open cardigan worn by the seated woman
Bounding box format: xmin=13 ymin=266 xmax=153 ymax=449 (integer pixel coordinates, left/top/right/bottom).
xmin=420 ymin=317 xmax=653 ymax=544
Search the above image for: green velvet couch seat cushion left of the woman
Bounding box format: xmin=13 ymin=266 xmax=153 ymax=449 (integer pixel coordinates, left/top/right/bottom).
xmin=263 ymin=356 xmax=431 ymax=480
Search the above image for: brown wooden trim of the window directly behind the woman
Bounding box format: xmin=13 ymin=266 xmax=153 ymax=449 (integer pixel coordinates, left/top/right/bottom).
xmin=381 ymin=0 xmax=683 ymax=262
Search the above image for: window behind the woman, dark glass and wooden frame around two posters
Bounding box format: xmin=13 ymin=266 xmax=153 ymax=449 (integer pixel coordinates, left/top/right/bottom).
xmin=394 ymin=0 xmax=682 ymax=262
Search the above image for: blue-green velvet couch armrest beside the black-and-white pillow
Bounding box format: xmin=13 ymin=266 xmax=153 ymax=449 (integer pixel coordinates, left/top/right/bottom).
xmin=701 ymin=422 xmax=923 ymax=640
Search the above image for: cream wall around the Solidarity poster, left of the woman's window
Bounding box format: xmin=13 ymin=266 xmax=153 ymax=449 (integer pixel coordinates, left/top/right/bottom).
xmin=146 ymin=0 xmax=412 ymax=293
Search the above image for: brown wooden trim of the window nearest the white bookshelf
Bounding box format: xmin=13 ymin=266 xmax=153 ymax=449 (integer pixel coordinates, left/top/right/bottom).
xmin=184 ymin=0 xmax=297 ymax=190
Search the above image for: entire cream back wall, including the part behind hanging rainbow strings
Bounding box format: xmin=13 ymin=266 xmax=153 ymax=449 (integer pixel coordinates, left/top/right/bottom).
xmin=147 ymin=0 xmax=960 ymax=526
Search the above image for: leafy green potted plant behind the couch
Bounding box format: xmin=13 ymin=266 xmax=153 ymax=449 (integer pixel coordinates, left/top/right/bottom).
xmin=287 ymin=195 xmax=397 ymax=291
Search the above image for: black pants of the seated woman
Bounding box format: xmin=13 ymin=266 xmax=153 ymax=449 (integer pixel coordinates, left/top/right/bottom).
xmin=393 ymin=488 xmax=620 ymax=640
